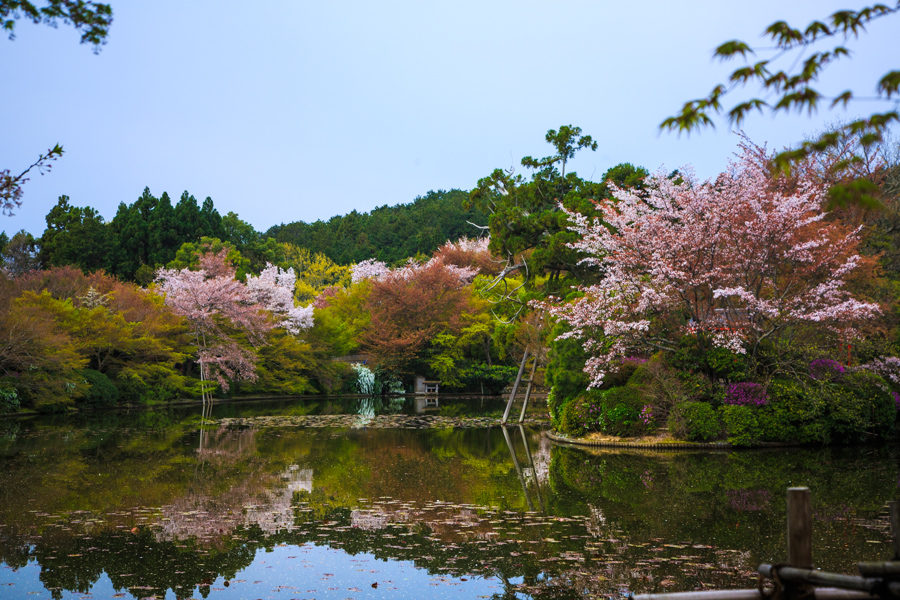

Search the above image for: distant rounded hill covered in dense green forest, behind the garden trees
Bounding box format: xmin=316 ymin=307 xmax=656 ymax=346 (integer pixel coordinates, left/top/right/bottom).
xmin=265 ymin=190 xmax=487 ymax=265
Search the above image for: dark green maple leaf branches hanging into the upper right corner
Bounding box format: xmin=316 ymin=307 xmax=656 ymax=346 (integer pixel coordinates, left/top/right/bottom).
xmin=660 ymin=2 xmax=900 ymax=207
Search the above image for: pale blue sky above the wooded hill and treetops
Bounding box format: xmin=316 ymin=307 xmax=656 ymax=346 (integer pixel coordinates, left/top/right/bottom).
xmin=0 ymin=0 xmax=900 ymax=235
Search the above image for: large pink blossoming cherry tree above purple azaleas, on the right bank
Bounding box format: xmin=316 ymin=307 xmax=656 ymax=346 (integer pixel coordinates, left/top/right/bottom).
xmin=546 ymin=142 xmax=879 ymax=386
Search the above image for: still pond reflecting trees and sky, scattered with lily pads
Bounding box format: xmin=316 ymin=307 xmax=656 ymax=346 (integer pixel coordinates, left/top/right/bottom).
xmin=0 ymin=399 xmax=900 ymax=600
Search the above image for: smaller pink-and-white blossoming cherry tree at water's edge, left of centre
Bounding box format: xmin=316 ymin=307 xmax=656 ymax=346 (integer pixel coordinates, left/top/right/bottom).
xmin=157 ymin=250 xmax=312 ymax=405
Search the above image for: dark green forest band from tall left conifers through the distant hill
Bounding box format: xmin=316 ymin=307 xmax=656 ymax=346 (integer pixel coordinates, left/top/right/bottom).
xmin=0 ymin=188 xmax=487 ymax=285
